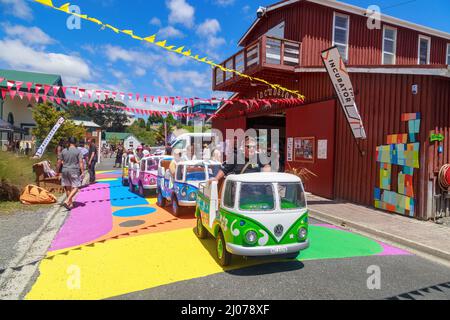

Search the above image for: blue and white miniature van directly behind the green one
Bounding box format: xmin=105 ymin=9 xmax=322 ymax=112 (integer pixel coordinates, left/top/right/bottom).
xmin=157 ymin=160 xmax=220 ymax=216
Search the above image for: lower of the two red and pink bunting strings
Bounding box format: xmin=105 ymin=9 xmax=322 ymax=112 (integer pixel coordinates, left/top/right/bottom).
xmin=0 ymin=87 xmax=303 ymax=119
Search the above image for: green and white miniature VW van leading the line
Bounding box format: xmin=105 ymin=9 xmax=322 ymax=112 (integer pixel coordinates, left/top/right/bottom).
xmin=196 ymin=172 xmax=309 ymax=266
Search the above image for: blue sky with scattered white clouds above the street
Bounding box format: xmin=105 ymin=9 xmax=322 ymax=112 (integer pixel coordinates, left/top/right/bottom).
xmin=0 ymin=0 xmax=450 ymax=108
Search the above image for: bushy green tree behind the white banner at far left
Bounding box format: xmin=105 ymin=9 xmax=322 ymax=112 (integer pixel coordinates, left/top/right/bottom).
xmin=32 ymin=103 xmax=86 ymax=148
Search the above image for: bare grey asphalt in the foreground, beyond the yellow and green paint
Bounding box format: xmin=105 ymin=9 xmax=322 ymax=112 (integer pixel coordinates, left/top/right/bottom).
xmin=113 ymin=219 xmax=450 ymax=300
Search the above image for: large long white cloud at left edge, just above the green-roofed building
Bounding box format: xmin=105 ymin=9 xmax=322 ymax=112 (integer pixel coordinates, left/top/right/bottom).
xmin=0 ymin=39 xmax=91 ymax=84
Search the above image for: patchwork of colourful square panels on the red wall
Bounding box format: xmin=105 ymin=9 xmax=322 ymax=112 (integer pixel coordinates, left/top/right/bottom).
xmin=374 ymin=113 xmax=420 ymax=217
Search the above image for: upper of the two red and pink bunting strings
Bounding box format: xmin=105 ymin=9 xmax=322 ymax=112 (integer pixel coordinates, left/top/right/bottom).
xmin=0 ymin=78 xmax=304 ymax=106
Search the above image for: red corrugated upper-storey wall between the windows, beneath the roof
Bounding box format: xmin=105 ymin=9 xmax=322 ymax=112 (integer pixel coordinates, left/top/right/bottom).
xmin=245 ymin=2 xmax=449 ymax=67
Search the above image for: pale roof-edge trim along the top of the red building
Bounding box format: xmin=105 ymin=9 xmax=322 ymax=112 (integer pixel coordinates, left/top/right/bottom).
xmin=238 ymin=0 xmax=450 ymax=46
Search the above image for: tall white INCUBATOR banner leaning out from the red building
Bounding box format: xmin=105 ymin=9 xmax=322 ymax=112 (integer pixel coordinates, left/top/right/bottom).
xmin=322 ymin=47 xmax=367 ymax=140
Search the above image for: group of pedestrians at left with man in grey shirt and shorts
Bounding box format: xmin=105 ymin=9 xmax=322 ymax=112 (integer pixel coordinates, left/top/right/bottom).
xmin=56 ymin=137 xmax=98 ymax=210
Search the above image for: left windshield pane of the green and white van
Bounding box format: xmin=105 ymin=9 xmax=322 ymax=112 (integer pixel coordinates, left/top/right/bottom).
xmin=239 ymin=183 xmax=275 ymax=211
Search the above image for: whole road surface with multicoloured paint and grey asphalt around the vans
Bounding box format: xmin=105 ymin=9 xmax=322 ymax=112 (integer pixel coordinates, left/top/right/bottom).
xmin=26 ymin=171 xmax=450 ymax=299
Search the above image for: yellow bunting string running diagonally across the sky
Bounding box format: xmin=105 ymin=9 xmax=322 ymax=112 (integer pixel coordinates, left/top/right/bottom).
xmin=33 ymin=0 xmax=305 ymax=100
